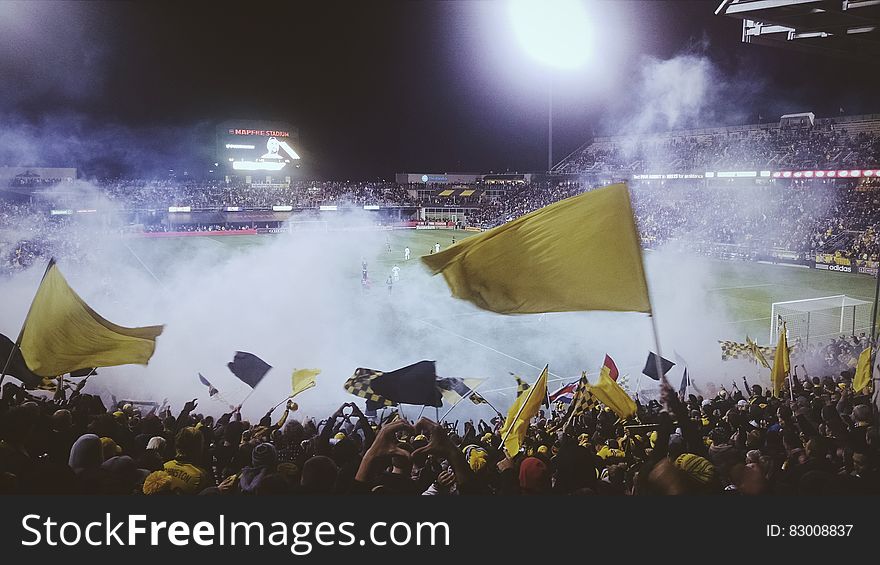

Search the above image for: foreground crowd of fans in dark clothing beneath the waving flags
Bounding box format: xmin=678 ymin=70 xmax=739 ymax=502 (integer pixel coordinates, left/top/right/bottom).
xmin=0 ymin=340 xmax=880 ymax=496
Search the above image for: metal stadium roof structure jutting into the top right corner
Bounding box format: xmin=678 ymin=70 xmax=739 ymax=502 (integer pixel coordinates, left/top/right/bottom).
xmin=715 ymin=0 xmax=880 ymax=62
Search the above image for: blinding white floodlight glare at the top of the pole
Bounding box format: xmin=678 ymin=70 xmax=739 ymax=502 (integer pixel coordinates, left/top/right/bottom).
xmin=510 ymin=0 xmax=590 ymax=69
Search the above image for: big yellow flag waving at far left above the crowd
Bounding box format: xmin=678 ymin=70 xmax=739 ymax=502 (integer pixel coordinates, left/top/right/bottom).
xmin=21 ymin=260 xmax=162 ymax=377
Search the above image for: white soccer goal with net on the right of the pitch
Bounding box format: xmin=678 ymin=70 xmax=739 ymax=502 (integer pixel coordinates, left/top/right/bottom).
xmin=770 ymin=294 xmax=872 ymax=344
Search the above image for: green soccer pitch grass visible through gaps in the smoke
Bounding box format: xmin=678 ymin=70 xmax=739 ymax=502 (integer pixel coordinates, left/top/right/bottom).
xmin=122 ymin=229 xmax=874 ymax=343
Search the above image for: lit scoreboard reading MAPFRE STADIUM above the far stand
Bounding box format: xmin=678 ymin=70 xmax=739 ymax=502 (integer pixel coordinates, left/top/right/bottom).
xmin=217 ymin=120 xmax=300 ymax=174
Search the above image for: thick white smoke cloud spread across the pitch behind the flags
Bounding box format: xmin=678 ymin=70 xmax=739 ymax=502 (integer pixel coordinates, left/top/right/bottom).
xmin=0 ymin=184 xmax=756 ymax=419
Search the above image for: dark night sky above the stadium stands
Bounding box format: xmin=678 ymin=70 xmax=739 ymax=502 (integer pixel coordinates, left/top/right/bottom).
xmin=0 ymin=0 xmax=880 ymax=179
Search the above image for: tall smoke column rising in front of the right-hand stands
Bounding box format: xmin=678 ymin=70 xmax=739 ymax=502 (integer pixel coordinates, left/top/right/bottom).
xmin=580 ymin=47 xmax=796 ymax=387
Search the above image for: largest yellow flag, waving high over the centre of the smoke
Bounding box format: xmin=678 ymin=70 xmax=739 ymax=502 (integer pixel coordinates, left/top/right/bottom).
xmin=422 ymin=184 xmax=651 ymax=314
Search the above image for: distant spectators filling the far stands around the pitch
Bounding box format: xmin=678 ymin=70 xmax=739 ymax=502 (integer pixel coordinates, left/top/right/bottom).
xmin=0 ymin=113 xmax=880 ymax=271
